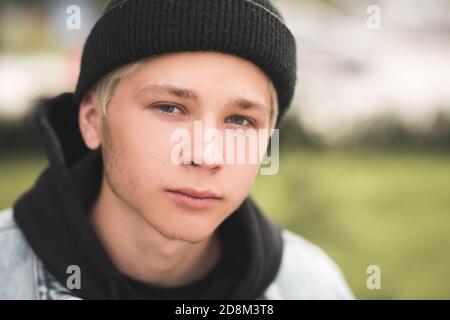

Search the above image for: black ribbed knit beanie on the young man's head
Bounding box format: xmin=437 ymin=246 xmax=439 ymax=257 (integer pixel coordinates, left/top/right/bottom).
xmin=75 ymin=0 xmax=297 ymax=127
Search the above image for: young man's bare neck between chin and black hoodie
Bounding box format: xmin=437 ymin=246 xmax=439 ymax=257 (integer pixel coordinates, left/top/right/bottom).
xmin=90 ymin=178 xmax=220 ymax=287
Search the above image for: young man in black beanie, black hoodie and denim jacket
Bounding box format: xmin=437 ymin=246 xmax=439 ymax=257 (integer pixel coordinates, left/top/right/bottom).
xmin=0 ymin=0 xmax=352 ymax=299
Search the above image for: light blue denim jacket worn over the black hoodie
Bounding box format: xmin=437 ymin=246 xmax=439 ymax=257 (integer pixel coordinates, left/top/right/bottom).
xmin=0 ymin=209 xmax=354 ymax=300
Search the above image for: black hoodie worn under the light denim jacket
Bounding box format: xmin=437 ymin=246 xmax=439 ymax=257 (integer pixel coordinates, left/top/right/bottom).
xmin=14 ymin=93 xmax=283 ymax=299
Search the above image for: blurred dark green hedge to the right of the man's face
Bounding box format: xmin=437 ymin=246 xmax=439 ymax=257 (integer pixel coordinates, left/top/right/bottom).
xmin=280 ymin=111 xmax=450 ymax=152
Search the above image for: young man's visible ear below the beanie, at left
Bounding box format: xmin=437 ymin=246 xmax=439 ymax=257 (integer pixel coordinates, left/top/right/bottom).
xmin=78 ymin=91 xmax=101 ymax=150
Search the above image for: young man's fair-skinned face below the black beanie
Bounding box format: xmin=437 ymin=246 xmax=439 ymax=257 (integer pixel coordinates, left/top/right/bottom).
xmin=80 ymin=52 xmax=272 ymax=242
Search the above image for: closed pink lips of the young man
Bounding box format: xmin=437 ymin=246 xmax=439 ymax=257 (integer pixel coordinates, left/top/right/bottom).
xmin=165 ymin=188 xmax=222 ymax=209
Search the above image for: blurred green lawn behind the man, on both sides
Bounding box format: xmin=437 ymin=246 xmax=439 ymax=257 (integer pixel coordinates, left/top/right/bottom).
xmin=0 ymin=151 xmax=450 ymax=299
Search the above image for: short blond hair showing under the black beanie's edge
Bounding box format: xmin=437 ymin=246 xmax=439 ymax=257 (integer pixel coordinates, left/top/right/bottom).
xmin=94 ymin=60 xmax=278 ymax=129
